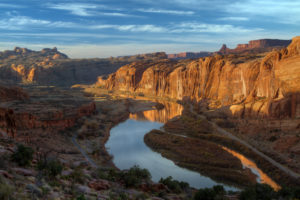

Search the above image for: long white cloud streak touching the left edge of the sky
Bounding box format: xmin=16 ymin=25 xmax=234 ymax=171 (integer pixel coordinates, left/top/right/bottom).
xmin=0 ymin=16 xmax=75 ymax=30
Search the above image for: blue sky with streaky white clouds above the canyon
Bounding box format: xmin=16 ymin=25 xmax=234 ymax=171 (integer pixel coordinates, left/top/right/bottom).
xmin=0 ymin=0 xmax=300 ymax=58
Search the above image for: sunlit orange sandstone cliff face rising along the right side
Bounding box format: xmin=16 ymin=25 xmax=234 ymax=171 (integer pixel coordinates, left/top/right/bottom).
xmin=97 ymin=37 xmax=300 ymax=117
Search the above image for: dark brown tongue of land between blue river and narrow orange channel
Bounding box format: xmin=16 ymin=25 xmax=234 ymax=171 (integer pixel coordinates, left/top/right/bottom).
xmin=144 ymin=130 xmax=256 ymax=188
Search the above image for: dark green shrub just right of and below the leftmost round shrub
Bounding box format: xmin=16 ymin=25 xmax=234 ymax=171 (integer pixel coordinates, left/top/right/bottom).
xmin=37 ymin=159 xmax=63 ymax=178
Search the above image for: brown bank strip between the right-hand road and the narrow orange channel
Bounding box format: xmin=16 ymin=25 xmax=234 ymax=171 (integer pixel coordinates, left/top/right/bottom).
xmin=155 ymin=104 xmax=299 ymax=186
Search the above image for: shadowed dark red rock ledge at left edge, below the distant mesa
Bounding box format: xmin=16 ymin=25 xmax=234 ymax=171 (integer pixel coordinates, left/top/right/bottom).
xmin=0 ymin=86 xmax=96 ymax=137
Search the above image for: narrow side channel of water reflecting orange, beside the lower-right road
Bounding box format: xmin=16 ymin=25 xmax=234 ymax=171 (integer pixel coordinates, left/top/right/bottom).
xmin=223 ymin=147 xmax=281 ymax=191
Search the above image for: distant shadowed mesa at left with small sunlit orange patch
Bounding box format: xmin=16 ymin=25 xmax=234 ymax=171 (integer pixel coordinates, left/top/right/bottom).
xmin=0 ymin=47 xmax=167 ymax=86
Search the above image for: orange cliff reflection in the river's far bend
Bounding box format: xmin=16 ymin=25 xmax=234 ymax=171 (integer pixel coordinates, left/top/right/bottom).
xmin=129 ymin=101 xmax=183 ymax=123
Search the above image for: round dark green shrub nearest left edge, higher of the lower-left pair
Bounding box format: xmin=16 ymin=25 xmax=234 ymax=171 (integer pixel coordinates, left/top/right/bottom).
xmin=11 ymin=144 xmax=34 ymax=166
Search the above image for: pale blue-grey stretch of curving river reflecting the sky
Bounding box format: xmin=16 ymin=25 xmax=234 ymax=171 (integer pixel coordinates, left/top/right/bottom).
xmin=105 ymin=119 xmax=237 ymax=190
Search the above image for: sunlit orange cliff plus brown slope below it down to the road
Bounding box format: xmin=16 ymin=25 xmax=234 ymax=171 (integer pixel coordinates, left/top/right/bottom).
xmin=95 ymin=37 xmax=300 ymax=186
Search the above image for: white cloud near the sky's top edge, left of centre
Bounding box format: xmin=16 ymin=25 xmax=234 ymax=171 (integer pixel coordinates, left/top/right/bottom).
xmin=47 ymin=3 xmax=99 ymax=17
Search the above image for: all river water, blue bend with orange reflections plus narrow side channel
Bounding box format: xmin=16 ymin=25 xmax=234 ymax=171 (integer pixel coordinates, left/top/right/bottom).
xmin=105 ymin=102 xmax=276 ymax=191
